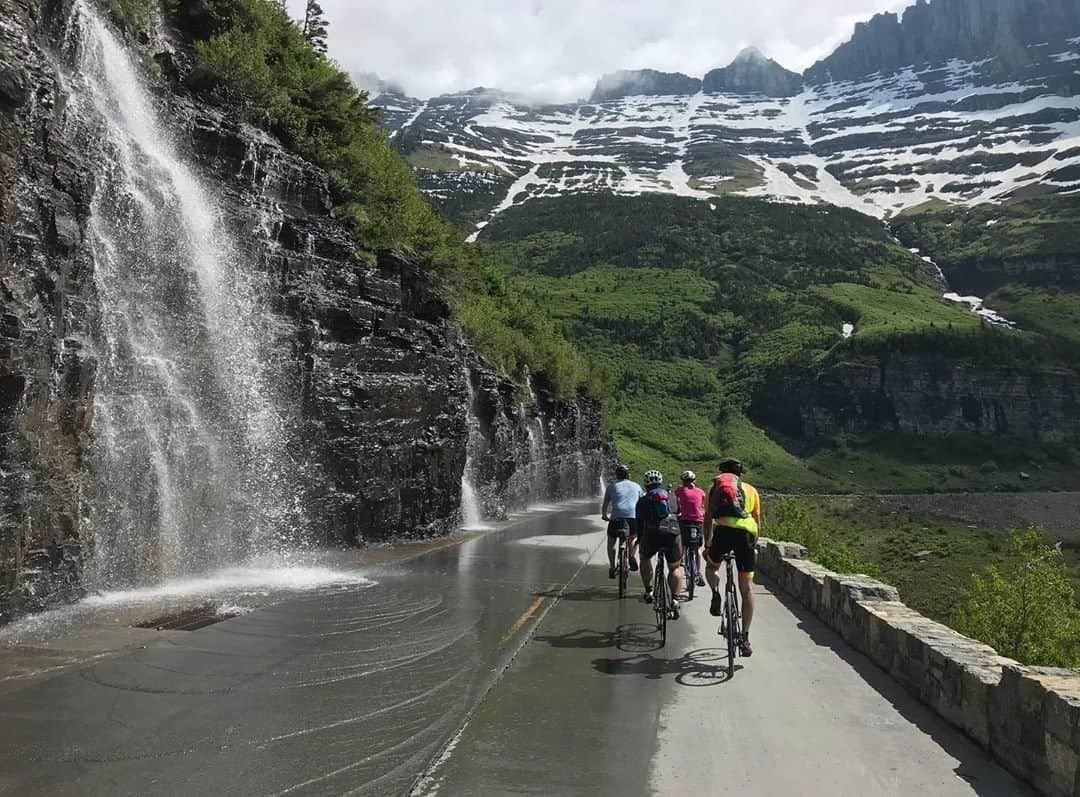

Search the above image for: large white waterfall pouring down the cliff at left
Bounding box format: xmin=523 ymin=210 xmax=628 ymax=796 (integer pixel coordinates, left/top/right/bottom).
xmin=64 ymin=0 xmax=305 ymax=589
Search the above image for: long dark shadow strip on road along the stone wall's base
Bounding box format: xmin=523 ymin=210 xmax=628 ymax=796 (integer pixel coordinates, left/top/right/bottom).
xmin=760 ymin=580 xmax=1036 ymax=797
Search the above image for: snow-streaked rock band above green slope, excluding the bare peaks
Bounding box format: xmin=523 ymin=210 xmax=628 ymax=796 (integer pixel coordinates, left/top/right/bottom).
xmin=375 ymin=39 xmax=1080 ymax=230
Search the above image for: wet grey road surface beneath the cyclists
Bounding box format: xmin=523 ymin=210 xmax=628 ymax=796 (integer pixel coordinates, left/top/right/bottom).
xmin=0 ymin=504 xmax=1025 ymax=797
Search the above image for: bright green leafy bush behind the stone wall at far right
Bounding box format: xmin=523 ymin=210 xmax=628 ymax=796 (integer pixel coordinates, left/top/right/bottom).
xmin=951 ymin=528 xmax=1080 ymax=667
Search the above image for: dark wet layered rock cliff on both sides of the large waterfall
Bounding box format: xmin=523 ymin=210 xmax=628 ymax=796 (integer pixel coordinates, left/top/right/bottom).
xmin=0 ymin=0 xmax=605 ymax=622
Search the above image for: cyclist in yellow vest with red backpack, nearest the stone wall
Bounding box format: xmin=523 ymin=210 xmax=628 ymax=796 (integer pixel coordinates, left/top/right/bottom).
xmin=705 ymin=459 xmax=761 ymax=656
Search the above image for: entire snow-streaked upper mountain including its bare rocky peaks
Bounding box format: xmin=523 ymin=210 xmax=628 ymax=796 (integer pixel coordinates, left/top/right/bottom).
xmin=375 ymin=0 xmax=1080 ymax=231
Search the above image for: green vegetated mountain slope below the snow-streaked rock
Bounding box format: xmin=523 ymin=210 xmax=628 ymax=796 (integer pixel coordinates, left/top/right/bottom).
xmin=481 ymin=195 xmax=1076 ymax=491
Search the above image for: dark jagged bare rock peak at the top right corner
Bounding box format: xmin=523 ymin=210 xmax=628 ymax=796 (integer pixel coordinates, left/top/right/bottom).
xmin=806 ymin=0 xmax=1080 ymax=83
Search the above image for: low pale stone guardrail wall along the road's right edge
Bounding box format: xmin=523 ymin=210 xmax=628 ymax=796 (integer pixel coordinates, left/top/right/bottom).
xmin=758 ymin=539 xmax=1080 ymax=797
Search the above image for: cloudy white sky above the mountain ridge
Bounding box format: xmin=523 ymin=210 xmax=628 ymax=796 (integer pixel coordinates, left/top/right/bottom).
xmin=288 ymin=0 xmax=914 ymax=100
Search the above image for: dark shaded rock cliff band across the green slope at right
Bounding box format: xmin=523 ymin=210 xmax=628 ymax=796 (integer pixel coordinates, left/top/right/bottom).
xmin=752 ymin=355 xmax=1080 ymax=443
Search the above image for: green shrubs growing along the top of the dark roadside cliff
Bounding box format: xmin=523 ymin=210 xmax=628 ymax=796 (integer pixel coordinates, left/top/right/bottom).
xmin=162 ymin=0 xmax=597 ymax=394
